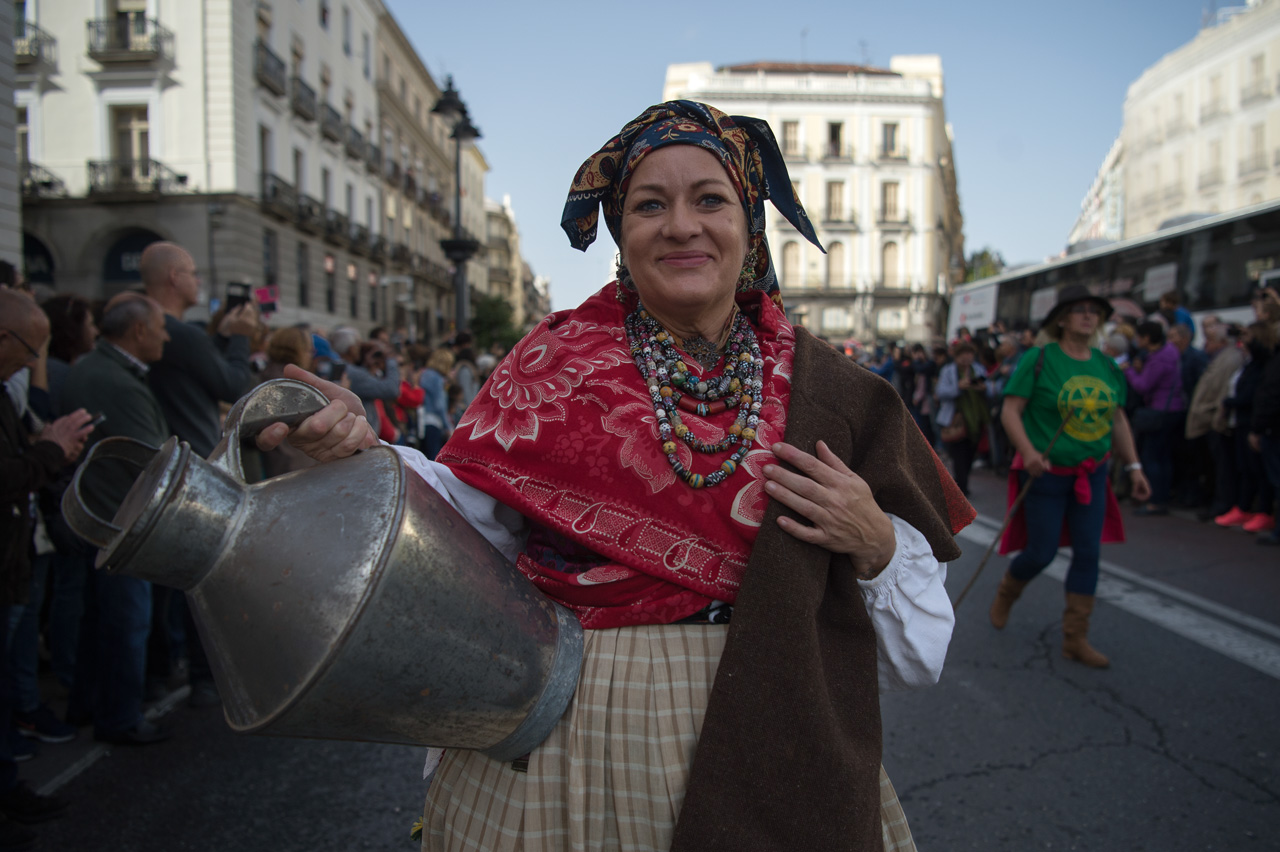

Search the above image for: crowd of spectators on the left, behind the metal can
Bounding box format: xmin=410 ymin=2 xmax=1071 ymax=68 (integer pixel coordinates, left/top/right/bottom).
xmin=0 ymin=243 xmax=503 ymax=849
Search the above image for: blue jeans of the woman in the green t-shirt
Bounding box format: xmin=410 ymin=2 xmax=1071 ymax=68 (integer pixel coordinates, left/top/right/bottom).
xmin=1009 ymin=464 xmax=1108 ymax=595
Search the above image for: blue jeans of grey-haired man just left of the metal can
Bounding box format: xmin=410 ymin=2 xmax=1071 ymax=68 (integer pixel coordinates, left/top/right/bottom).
xmin=68 ymin=572 xmax=151 ymax=734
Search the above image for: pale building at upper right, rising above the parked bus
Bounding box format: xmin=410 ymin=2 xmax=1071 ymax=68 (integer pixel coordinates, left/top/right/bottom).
xmin=1120 ymin=0 xmax=1280 ymax=238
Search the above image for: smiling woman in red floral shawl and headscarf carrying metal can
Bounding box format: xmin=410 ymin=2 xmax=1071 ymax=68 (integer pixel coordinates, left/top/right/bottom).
xmin=266 ymin=101 xmax=974 ymax=852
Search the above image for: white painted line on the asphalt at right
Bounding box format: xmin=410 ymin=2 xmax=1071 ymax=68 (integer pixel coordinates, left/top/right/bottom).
xmin=959 ymin=518 xmax=1280 ymax=679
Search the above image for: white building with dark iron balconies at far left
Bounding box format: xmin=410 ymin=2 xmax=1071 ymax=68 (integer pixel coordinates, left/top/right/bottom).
xmin=17 ymin=0 xmax=385 ymax=327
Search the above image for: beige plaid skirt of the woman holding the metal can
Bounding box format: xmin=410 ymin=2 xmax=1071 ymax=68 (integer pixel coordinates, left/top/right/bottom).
xmin=422 ymin=624 xmax=915 ymax=852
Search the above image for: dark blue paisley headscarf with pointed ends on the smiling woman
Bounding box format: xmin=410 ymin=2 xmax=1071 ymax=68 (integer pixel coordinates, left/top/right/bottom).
xmin=561 ymin=101 xmax=822 ymax=302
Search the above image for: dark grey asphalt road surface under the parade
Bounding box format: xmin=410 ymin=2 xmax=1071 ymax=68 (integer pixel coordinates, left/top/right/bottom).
xmin=23 ymin=471 xmax=1280 ymax=852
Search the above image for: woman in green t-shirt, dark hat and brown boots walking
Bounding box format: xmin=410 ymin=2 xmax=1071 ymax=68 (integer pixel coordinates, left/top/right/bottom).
xmin=991 ymin=284 xmax=1151 ymax=668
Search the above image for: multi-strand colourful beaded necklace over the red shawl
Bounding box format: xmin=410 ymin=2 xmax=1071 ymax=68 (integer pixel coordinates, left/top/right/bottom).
xmin=626 ymin=304 xmax=764 ymax=489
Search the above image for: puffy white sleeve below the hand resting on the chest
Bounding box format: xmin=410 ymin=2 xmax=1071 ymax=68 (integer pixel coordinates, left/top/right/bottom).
xmin=858 ymin=514 xmax=955 ymax=692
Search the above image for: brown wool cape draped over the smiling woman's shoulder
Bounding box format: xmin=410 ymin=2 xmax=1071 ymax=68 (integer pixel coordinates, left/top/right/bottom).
xmin=671 ymin=327 xmax=974 ymax=852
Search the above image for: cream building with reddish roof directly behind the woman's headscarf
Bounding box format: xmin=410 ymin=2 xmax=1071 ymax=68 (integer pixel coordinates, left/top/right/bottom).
xmin=663 ymin=56 xmax=964 ymax=343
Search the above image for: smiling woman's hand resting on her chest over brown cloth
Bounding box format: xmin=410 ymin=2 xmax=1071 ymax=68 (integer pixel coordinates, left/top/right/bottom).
xmin=764 ymin=441 xmax=897 ymax=580
